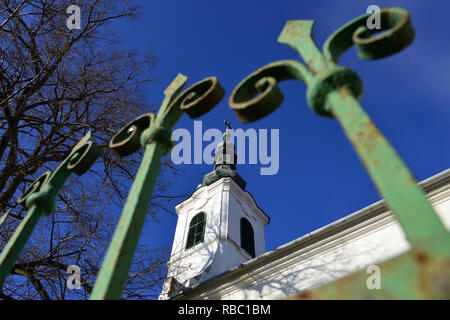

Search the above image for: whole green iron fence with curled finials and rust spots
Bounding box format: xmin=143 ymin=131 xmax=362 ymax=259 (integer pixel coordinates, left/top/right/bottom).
xmin=0 ymin=8 xmax=450 ymax=299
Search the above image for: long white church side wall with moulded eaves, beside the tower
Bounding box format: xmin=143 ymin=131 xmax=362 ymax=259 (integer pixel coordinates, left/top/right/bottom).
xmin=171 ymin=170 xmax=450 ymax=300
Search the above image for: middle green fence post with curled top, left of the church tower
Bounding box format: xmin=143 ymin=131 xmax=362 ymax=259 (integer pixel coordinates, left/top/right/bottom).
xmin=90 ymin=74 xmax=225 ymax=300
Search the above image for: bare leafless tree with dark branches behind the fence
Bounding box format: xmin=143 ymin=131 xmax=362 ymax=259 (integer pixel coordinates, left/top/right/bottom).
xmin=0 ymin=0 xmax=179 ymax=299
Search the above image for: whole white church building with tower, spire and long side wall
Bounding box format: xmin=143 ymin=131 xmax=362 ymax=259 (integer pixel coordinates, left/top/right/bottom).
xmin=159 ymin=125 xmax=450 ymax=300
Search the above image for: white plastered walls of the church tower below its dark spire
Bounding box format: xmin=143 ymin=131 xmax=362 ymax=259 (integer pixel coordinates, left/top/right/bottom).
xmin=168 ymin=178 xmax=265 ymax=287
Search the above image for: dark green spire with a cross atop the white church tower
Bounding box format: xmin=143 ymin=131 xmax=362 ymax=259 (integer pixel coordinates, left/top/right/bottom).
xmin=203 ymin=120 xmax=247 ymax=190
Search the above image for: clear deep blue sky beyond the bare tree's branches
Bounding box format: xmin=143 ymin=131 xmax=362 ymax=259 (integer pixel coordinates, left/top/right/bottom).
xmin=111 ymin=0 xmax=450 ymax=272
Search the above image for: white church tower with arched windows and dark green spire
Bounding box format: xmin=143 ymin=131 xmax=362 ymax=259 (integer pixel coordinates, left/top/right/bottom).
xmin=159 ymin=122 xmax=269 ymax=299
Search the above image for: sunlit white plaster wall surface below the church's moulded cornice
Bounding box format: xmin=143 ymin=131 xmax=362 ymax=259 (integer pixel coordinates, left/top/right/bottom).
xmin=218 ymin=215 xmax=409 ymax=299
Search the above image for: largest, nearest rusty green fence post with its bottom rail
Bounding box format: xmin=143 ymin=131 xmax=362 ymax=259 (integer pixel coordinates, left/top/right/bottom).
xmin=229 ymin=8 xmax=450 ymax=299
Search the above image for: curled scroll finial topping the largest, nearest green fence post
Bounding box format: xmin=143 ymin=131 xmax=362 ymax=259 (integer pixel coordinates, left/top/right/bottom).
xmin=229 ymin=8 xmax=414 ymax=123
